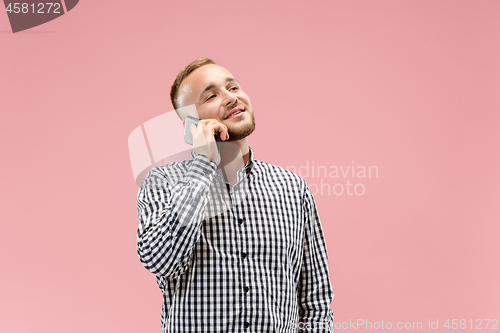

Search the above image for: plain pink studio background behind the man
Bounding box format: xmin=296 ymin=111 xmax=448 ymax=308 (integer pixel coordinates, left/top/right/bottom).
xmin=0 ymin=0 xmax=500 ymax=333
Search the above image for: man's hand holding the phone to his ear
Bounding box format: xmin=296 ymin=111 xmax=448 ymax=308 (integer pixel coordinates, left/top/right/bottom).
xmin=191 ymin=119 xmax=229 ymax=165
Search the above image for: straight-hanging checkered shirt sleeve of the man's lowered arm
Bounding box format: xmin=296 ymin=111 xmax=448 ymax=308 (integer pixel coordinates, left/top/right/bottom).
xmin=298 ymin=185 xmax=333 ymax=333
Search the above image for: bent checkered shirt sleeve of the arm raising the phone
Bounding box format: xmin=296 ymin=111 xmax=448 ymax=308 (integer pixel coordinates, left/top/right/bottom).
xmin=137 ymin=155 xmax=217 ymax=278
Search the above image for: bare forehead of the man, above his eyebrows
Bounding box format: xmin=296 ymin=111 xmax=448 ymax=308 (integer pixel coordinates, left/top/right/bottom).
xmin=179 ymin=64 xmax=233 ymax=94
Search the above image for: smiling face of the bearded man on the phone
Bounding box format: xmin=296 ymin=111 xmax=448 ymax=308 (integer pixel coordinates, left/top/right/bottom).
xmin=178 ymin=64 xmax=255 ymax=141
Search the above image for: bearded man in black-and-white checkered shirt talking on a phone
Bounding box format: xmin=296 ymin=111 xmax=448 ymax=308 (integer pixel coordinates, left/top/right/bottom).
xmin=137 ymin=58 xmax=333 ymax=333
